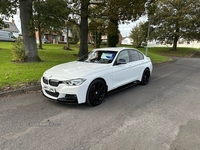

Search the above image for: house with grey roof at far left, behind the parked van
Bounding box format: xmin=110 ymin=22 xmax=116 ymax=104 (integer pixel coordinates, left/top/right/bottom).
xmin=1 ymin=19 xmax=19 ymax=37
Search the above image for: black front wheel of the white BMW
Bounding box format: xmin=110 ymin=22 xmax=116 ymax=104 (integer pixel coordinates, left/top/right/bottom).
xmin=86 ymin=79 xmax=107 ymax=106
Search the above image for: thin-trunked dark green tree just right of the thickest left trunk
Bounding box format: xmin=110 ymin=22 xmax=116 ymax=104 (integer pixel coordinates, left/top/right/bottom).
xmin=34 ymin=0 xmax=69 ymax=49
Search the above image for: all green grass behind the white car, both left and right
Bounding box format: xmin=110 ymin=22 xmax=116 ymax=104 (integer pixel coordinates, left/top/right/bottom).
xmin=0 ymin=42 xmax=198 ymax=89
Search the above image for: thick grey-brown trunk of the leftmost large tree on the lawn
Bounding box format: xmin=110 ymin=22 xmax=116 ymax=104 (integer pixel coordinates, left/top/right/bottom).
xmin=19 ymin=0 xmax=41 ymax=62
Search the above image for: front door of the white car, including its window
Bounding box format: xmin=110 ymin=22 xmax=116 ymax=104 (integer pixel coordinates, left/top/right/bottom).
xmin=112 ymin=50 xmax=132 ymax=88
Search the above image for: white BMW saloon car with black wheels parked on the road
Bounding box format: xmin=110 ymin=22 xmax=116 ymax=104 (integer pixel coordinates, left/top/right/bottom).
xmin=41 ymin=47 xmax=153 ymax=106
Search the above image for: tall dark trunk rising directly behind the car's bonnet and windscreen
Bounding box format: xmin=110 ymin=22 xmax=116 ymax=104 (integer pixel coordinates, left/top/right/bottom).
xmin=78 ymin=0 xmax=89 ymax=57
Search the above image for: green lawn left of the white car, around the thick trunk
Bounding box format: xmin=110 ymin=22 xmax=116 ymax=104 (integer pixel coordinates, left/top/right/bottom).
xmin=0 ymin=42 xmax=78 ymax=88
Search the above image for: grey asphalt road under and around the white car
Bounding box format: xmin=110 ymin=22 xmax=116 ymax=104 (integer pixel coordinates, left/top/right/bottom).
xmin=0 ymin=58 xmax=200 ymax=150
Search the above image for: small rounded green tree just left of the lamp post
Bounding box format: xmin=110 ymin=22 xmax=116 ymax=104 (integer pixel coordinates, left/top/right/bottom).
xmin=130 ymin=22 xmax=148 ymax=48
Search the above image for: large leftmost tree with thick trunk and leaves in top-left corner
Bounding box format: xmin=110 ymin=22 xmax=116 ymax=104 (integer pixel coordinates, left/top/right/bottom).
xmin=0 ymin=0 xmax=40 ymax=61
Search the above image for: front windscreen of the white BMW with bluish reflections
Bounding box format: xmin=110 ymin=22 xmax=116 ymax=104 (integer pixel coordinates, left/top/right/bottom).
xmin=78 ymin=50 xmax=117 ymax=64
